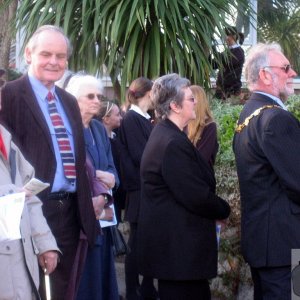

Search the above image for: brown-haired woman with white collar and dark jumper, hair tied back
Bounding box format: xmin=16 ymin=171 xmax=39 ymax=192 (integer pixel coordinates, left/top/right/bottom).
xmin=119 ymin=77 xmax=157 ymax=300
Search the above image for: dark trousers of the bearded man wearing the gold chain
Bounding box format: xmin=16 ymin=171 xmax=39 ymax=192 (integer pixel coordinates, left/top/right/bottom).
xmin=251 ymin=266 xmax=291 ymax=300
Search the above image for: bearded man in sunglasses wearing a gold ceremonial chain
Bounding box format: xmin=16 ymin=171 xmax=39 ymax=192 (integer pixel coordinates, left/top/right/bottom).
xmin=233 ymin=43 xmax=300 ymax=300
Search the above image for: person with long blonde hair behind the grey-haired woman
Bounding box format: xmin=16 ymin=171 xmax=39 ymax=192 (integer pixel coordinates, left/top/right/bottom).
xmin=187 ymin=85 xmax=219 ymax=167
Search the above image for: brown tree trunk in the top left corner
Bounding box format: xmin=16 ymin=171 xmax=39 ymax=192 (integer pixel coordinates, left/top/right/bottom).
xmin=0 ymin=0 xmax=18 ymax=69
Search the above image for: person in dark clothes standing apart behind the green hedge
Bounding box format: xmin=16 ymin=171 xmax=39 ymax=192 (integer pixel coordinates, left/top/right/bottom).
xmin=213 ymin=26 xmax=245 ymax=100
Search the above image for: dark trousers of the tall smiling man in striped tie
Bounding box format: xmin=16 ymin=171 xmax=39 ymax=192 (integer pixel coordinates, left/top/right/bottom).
xmin=40 ymin=194 xmax=80 ymax=300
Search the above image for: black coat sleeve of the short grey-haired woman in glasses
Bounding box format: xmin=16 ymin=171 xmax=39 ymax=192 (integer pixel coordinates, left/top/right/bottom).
xmin=162 ymin=140 xmax=230 ymax=219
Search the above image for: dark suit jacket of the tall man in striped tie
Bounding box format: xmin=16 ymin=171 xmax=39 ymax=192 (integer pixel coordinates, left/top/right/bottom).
xmin=0 ymin=75 xmax=99 ymax=244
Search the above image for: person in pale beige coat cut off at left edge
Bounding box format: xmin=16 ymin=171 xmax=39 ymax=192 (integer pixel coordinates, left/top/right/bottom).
xmin=0 ymin=69 xmax=59 ymax=300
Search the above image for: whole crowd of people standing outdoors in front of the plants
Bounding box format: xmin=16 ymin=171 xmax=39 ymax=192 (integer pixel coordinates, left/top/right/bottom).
xmin=0 ymin=25 xmax=300 ymax=300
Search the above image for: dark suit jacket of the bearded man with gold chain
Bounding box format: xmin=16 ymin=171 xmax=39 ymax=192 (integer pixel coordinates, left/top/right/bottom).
xmin=233 ymin=93 xmax=300 ymax=267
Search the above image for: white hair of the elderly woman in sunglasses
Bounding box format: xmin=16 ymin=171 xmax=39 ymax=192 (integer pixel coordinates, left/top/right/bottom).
xmin=65 ymin=74 xmax=104 ymax=100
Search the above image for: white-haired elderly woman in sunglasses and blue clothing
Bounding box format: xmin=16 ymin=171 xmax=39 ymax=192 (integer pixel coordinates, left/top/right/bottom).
xmin=66 ymin=75 xmax=119 ymax=300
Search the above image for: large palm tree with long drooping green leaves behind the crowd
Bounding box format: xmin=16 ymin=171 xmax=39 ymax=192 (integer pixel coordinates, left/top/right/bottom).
xmin=16 ymin=0 xmax=248 ymax=101
